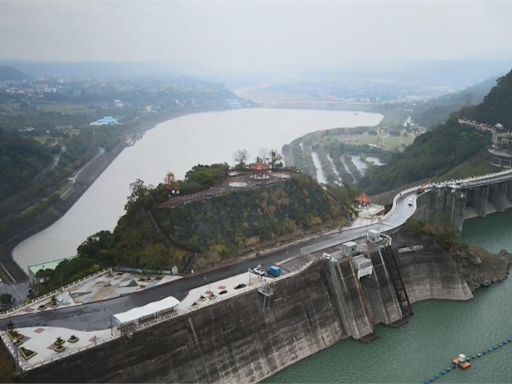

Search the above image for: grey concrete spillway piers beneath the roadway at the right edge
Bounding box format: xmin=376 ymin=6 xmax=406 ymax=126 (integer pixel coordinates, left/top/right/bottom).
xmin=413 ymin=170 xmax=512 ymax=232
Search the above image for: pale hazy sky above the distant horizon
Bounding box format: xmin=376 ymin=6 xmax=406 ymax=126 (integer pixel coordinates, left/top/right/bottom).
xmin=0 ymin=0 xmax=512 ymax=73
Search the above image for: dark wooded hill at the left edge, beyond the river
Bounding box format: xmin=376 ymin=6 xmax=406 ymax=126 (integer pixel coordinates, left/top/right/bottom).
xmin=0 ymin=129 xmax=52 ymax=201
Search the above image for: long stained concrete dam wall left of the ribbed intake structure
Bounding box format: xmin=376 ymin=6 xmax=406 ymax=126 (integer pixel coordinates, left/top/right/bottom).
xmin=19 ymin=262 xmax=348 ymax=383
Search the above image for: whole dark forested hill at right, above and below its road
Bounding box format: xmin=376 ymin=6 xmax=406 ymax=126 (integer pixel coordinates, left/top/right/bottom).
xmin=359 ymin=67 xmax=512 ymax=194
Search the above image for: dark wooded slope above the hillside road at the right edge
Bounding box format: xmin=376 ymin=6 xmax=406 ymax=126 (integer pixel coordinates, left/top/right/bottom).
xmin=463 ymin=71 xmax=512 ymax=129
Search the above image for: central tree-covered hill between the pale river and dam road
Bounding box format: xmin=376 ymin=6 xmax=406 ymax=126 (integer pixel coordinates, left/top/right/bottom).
xmin=37 ymin=164 xmax=353 ymax=292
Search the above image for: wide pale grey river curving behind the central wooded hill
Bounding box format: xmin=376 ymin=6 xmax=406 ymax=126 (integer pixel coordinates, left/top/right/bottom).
xmin=13 ymin=108 xmax=382 ymax=270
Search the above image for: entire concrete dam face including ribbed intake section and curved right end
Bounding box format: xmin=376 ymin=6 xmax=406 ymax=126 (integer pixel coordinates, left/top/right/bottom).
xmin=14 ymin=240 xmax=471 ymax=383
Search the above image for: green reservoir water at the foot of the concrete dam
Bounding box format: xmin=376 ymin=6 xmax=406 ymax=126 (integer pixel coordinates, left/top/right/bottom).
xmin=267 ymin=210 xmax=512 ymax=383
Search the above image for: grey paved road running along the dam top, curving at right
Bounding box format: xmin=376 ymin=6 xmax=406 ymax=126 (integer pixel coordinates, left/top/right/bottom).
xmin=0 ymin=190 xmax=422 ymax=331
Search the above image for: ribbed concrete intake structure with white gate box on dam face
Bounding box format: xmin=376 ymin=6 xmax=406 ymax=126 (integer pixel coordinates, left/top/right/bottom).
xmin=323 ymin=231 xmax=412 ymax=340
